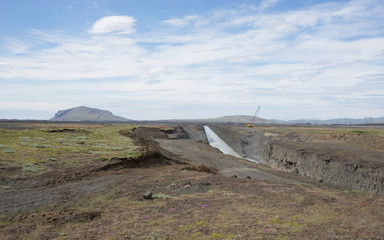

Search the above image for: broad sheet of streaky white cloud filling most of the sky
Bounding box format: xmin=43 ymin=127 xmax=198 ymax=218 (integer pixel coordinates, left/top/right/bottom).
xmin=0 ymin=0 xmax=384 ymax=119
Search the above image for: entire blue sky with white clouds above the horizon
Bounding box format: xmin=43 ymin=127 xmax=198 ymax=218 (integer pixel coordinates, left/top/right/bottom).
xmin=0 ymin=0 xmax=384 ymax=120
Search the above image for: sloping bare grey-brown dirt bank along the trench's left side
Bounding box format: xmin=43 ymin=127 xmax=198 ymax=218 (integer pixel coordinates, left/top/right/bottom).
xmin=148 ymin=125 xmax=301 ymax=183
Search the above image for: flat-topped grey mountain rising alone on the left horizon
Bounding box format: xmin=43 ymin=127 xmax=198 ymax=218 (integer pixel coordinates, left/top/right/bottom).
xmin=50 ymin=106 xmax=131 ymax=122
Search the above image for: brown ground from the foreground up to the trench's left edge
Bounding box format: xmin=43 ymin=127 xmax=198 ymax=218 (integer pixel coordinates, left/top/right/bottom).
xmin=0 ymin=123 xmax=384 ymax=240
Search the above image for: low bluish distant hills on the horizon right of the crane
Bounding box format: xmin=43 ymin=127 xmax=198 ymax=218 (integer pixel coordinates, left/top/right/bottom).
xmin=272 ymin=117 xmax=384 ymax=124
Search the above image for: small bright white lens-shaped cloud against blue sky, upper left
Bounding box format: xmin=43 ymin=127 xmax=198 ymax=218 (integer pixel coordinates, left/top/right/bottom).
xmin=88 ymin=16 xmax=136 ymax=34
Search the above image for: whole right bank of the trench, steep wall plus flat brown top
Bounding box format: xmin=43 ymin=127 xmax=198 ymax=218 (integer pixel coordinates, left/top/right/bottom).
xmin=202 ymin=125 xmax=384 ymax=195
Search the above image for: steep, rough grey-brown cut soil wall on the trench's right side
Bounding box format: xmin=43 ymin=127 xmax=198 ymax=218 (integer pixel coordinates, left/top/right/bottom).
xmin=263 ymin=140 xmax=384 ymax=195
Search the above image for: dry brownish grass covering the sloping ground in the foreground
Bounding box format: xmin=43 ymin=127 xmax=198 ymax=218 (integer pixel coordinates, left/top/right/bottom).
xmin=1 ymin=166 xmax=384 ymax=240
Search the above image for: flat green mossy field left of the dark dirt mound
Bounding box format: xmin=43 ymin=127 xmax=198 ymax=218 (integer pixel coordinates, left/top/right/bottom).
xmin=0 ymin=124 xmax=139 ymax=177
